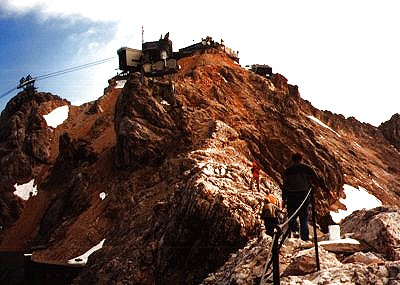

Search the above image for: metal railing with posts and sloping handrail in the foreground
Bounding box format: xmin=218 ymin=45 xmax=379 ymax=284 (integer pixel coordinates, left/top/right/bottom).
xmin=260 ymin=188 xmax=320 ymax=285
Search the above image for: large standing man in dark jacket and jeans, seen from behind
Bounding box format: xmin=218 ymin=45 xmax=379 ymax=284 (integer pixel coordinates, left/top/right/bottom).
xmin=282 ymin=153 xmax=326 ymax=241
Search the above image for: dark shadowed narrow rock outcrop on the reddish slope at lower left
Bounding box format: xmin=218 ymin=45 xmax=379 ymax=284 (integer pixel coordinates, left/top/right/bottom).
xmin=31 ymin=133 xmax=97 ymax=247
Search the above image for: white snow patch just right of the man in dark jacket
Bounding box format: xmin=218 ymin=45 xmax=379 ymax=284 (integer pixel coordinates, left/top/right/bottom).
xmin=331 ymin=184 xmax=382 ymax=223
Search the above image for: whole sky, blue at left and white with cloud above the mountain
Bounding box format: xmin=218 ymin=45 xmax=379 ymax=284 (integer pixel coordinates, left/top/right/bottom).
xmin=0 ymin=0 xmax=400 ymax=126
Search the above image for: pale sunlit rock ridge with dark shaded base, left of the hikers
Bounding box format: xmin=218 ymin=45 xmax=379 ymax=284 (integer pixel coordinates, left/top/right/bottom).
xmin=156 ymin=118 xmax=268 ymax=284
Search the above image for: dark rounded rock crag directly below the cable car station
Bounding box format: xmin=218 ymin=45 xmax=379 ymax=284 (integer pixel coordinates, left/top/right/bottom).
xmin=114 ymin=73 xmax=185 ymax=169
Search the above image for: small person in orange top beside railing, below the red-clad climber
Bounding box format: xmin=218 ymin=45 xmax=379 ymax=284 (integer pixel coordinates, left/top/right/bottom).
xmin=261 ymin=192 xmax=283 ymax=236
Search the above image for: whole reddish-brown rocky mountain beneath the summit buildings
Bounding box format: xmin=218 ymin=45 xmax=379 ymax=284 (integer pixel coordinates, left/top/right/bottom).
xmin=0 ymin=50 xmax=400 ymax=284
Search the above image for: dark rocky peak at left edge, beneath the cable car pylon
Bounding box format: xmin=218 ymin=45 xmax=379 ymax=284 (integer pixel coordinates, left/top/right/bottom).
xmin=0 ymin=90 xmax=69 ymax=227
